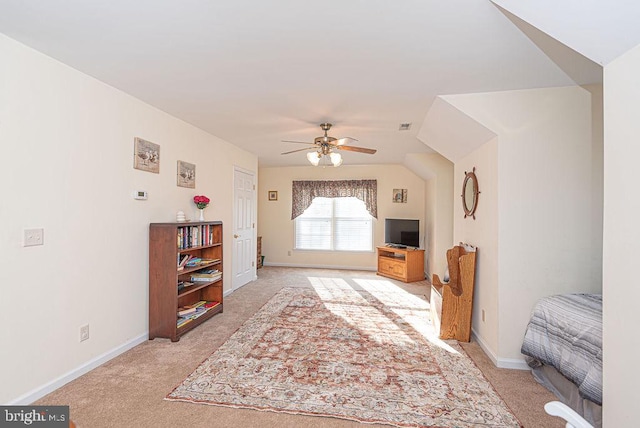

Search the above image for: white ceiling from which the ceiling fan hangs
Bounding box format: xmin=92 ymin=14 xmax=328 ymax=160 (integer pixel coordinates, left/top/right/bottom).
xmin=0 ymin=0 xmax=640 ymax=166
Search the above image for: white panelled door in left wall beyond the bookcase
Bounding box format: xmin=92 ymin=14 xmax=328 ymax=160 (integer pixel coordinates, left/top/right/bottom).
xmin=232 ymin=168 xmax=257 ymax=290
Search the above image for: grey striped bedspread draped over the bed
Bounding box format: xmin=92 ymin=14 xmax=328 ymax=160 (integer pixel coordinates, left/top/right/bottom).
xmin=521 ymin=294 xmax=602 ymax=405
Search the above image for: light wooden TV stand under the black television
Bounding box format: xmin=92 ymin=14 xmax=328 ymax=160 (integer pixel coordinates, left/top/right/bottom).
xmin=377 ymin=247 xmax=424 ymax=282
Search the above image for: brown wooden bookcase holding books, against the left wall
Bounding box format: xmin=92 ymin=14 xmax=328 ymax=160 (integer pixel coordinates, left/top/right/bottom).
xmin=149 ymin=221 xmax=224 ymax=342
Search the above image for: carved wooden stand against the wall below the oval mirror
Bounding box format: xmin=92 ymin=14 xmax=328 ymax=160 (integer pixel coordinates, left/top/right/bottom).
xmin=429 ymin=243 xmax=477 ymax=342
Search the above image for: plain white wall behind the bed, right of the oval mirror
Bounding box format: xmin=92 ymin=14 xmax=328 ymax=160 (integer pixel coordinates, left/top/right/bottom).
xmin=444 ymin=87 xmax=602 ymax=366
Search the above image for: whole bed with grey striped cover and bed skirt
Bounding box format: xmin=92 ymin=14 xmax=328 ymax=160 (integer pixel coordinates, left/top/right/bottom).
xmin=521 ymin=293 xmax=602 ymax=427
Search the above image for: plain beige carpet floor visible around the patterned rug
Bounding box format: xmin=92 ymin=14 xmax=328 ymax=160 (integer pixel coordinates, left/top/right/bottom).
xmin=34 ymin=267 xmax=564 ymax=428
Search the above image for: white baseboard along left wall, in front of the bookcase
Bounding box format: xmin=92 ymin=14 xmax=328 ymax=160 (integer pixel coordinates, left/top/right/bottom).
xmin=6 ymin=332 xmax=149 ymax=406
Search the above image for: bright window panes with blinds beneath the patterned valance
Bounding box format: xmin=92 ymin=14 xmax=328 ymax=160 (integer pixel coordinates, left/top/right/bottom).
xmin=295 ymin=197 xmax=373 ymax=251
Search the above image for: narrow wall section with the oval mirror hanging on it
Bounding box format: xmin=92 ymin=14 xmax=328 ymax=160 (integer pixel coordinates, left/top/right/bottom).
xmin=453 ymin=137 xmax=500 ymax=354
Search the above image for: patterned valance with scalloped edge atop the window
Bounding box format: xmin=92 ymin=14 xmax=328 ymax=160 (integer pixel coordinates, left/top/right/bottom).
xmin=291 ymin=180 xmax=378 ymax=220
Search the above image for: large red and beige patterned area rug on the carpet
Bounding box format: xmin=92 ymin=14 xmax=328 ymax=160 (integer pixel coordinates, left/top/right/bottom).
xmin=166 ymin=279 xmax=520 ymax=427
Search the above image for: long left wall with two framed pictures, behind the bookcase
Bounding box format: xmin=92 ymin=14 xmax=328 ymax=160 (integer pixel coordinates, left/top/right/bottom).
xmin=0 ymin=35 xmax=257 ymax=403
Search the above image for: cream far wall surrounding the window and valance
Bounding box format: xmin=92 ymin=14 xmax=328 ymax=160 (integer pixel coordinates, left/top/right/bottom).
xmin=258 ymin=165 xmax=425 ymax=270
